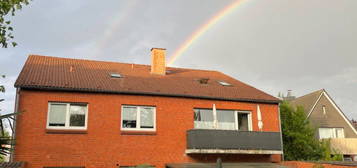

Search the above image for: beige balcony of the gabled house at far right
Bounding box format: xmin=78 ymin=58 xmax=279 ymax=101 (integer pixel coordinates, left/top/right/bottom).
xmin=330 ymin=138 xmax=357 ymax=155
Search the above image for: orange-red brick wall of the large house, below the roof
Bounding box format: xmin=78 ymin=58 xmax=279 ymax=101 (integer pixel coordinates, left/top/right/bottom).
xmin=14 ymin=90 xmax=280 ymax=168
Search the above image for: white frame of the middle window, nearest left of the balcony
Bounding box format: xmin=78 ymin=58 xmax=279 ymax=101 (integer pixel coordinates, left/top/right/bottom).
xmin=120 ymin=105 xmax=156 ymax=131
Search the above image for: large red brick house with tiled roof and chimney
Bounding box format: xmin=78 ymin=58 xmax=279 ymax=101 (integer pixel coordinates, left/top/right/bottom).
xmin=13 ymin=48 xmax=282 ymax=168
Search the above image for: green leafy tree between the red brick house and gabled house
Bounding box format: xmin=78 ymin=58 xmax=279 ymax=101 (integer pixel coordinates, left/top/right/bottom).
xmin=280 ymin=102 xmax=330 ymax=161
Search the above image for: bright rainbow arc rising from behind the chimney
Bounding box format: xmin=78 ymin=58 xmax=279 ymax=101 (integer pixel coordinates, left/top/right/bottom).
xmin=167 ymin=0 xmax=244 ymax=66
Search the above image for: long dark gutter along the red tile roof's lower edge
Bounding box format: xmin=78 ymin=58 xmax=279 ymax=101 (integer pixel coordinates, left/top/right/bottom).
xmin=15 ymin=86 xmax=280 ymax=104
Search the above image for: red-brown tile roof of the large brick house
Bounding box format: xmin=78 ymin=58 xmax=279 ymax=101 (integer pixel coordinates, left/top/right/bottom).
xmin=15 ymin=55 xmax=279 ymax=103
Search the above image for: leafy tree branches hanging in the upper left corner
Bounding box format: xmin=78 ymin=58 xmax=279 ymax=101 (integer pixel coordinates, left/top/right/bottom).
xmin=0 ymin=0 xmax=29 ymax=48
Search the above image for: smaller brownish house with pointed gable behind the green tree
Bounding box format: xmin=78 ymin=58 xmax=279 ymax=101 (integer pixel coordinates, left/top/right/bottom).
xmin=290 ymin=89 xmax=357 ymax=161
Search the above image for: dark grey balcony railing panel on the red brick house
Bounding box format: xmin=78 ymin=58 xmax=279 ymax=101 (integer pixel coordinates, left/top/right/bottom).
xmin=186 ymin=129 xmax=282 ymax=154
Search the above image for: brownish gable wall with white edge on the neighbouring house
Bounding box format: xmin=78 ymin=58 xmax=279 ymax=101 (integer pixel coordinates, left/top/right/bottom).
xmin=307 ymin=90 xmax=357 ymax=138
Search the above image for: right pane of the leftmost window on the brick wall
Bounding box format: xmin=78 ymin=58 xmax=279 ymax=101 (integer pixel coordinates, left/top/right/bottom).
xmin=69 ymin=105 xmax=87 ymax=127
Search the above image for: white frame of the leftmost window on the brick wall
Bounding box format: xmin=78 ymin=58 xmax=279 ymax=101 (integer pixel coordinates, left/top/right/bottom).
xmin=46 ymin=102 xmax=88 ymax=130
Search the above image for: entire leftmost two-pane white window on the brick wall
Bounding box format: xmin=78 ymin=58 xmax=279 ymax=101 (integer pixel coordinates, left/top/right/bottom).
xmin=47 ymin=103 xmax=88 ymax=129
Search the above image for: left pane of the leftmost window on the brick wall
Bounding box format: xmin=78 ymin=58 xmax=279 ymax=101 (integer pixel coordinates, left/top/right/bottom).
xmin=48 ymin=104 xmax=67 ymax=127
